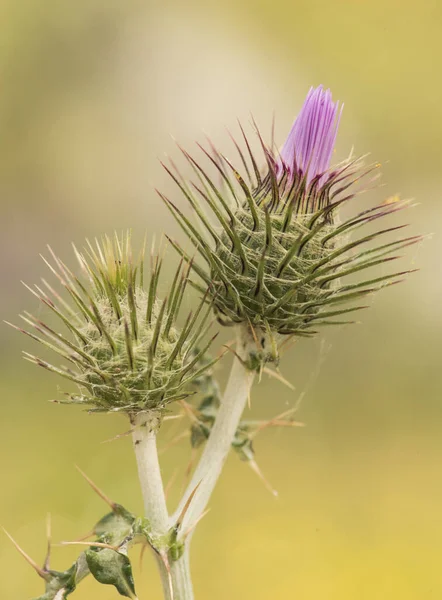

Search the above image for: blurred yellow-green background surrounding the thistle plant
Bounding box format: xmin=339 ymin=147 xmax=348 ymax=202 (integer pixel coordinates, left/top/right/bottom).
xmin=0 ymin=0 xmax=442 ymax=600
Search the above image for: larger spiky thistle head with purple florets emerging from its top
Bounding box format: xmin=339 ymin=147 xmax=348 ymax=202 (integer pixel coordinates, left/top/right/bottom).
xmin=160 ymin=87 xmax=421 ymax=363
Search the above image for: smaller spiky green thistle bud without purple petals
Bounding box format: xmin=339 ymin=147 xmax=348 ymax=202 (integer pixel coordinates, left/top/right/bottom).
xmin=10 ymin=235 xmax=216 ymax=417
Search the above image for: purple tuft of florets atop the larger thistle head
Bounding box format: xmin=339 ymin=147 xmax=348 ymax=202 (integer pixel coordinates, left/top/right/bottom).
xmin=278 ymin=85 xmax=342 ymax=185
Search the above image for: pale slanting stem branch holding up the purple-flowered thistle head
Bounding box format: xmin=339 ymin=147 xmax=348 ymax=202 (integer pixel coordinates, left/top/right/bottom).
xmin=174 ymin=327 xmax=256 ymax=534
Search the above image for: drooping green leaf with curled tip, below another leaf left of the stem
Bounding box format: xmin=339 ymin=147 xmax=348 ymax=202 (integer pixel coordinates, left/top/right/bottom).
xmin=85 ymin=547 xmax=137 ymax=600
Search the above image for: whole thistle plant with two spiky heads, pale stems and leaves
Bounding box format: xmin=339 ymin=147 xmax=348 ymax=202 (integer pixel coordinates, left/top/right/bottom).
xmin=7 ymin=87 xmax=421 ymax=600
